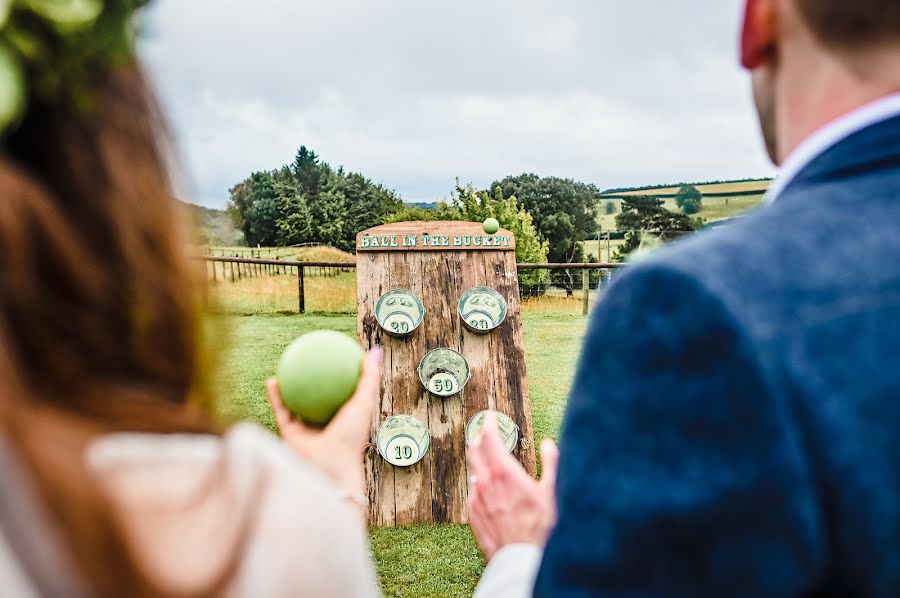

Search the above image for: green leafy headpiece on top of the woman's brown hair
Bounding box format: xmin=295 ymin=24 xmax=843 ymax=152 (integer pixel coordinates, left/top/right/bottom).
xmin=0 ymin=0 xmax=147 ymax=137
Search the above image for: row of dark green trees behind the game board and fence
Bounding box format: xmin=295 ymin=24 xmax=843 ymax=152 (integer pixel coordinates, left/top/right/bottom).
xmin=227 ymin=146 xmax=720 ymax=270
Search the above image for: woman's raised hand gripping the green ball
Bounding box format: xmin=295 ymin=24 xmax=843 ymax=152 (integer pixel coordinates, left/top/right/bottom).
xmin=266 ymin=348 xmax=382 ymax=496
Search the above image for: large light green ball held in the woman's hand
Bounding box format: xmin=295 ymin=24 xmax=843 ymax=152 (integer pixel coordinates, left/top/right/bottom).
xmin=275 ymin=330 xmax=365 ymax=426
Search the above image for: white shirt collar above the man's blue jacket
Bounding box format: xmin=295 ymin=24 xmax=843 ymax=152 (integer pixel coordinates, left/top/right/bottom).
xmin=765 ymin=93 xmax=900 ymax=204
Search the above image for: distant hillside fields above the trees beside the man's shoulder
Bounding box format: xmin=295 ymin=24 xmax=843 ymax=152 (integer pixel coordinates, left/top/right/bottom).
xmin=598 ymin=179 xmax=771 ymax=230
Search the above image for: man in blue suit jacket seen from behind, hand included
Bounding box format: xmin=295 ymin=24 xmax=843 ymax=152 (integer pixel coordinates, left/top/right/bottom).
xmin=469 ymin=0 xmax=900 ymax=597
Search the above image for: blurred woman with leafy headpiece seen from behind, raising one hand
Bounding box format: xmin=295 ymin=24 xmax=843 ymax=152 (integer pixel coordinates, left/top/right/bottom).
xmin=0 ymin=0 xmax=379 ymax=596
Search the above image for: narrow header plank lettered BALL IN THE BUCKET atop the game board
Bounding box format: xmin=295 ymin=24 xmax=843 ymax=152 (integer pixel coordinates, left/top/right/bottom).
xmin=356 ymin=222 xmax=516 ymax=253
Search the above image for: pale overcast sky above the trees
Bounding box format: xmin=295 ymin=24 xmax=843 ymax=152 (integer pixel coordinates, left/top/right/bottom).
xmin=142 ymin=0 xmax=773 ymax=207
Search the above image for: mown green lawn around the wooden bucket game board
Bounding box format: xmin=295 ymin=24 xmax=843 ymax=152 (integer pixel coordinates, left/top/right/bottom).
xmin=213 ymin=314 xmax=587 ymax=598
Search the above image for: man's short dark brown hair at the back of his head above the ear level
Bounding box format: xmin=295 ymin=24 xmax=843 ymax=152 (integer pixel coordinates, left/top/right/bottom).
xmin=796 ymin=0 xmax=900 ymax=49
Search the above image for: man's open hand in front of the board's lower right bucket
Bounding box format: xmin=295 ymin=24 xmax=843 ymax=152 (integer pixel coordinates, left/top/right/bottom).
xmin=466 ymin=413 xmax=559 ymax=560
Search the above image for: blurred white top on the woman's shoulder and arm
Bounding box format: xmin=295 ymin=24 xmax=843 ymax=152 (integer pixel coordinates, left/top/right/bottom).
xmin=0 ymin=424 xmax=379 ymax=598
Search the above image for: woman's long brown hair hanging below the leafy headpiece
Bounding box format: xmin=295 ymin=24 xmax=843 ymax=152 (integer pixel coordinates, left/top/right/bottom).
xmin=0 ymin=67 xmax=218 ymax=596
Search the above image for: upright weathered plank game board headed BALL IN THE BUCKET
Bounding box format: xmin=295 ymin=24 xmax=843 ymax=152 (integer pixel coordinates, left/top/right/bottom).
xmin=357 ymin=222 xmax=536 ymax=526
